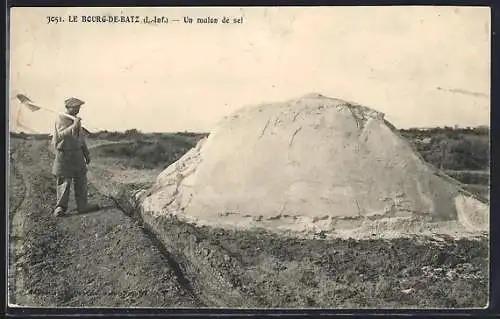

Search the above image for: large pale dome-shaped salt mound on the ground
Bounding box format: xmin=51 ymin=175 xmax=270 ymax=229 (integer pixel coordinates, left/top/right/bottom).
xmin=139 ymin=94 xmax=489 ymax=239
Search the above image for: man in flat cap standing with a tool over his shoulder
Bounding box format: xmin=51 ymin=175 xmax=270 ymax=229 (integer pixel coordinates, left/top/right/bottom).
xmin=52 ymin=97 xmax=99 ymax=216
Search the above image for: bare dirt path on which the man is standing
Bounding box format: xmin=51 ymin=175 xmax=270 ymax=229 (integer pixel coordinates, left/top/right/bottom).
xmin=10 ymin=140 xmax=203 ymax=307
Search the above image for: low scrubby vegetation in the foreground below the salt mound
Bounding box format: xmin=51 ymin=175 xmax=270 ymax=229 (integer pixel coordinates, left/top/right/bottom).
xmin=208 ymin=230 xmax=489 ymax=308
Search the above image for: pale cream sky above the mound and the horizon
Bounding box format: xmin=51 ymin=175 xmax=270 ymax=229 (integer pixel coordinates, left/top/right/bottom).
xmin=10 ymin=7 xmax=490 ymax=132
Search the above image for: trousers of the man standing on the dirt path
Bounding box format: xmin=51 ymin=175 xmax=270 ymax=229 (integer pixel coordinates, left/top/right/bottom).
xmin=56 ymin=172 xmax=88 ymax=211
